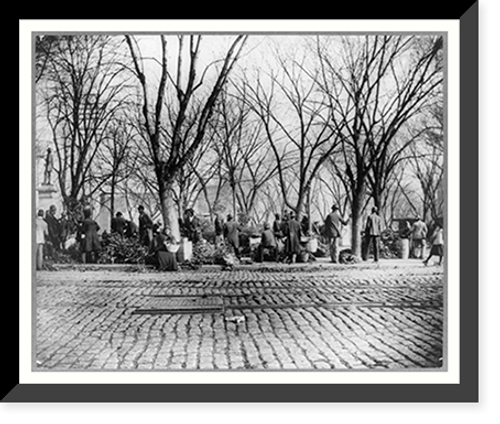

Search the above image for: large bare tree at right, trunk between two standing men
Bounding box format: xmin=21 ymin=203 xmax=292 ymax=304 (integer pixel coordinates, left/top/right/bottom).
xmin=314 ymin=36 xmax=442 ymax=255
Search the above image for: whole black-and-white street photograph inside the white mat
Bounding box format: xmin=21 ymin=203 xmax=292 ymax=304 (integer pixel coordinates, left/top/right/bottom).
xmin=28 ymin=24 xmax=450 ymax=375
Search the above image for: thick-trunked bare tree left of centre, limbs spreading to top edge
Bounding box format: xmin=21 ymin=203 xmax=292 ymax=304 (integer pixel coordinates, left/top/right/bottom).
xmin=125 ymin=35 xmax=246 ymax=240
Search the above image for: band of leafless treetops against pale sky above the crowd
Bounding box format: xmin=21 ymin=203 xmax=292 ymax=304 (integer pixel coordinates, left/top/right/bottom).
xmin=34 ymin=33 xmax=446 ymax=254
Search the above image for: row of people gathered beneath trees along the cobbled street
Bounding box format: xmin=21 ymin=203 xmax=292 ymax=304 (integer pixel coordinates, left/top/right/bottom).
xmin=36 ymin=197 xmax=444 ymax=270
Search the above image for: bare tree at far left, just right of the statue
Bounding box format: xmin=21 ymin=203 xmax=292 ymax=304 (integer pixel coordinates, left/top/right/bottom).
xmin=38 ymin=35 xmax=131 ymax=222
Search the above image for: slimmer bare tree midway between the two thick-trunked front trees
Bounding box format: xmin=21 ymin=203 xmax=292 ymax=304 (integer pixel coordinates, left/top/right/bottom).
xmin=240 ymin=50 xmax=340 ymax=222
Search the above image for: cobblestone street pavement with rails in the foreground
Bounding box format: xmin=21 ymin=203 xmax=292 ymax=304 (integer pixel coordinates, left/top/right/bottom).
xmin=34 ymin=261 xmax=444 ymax=370
